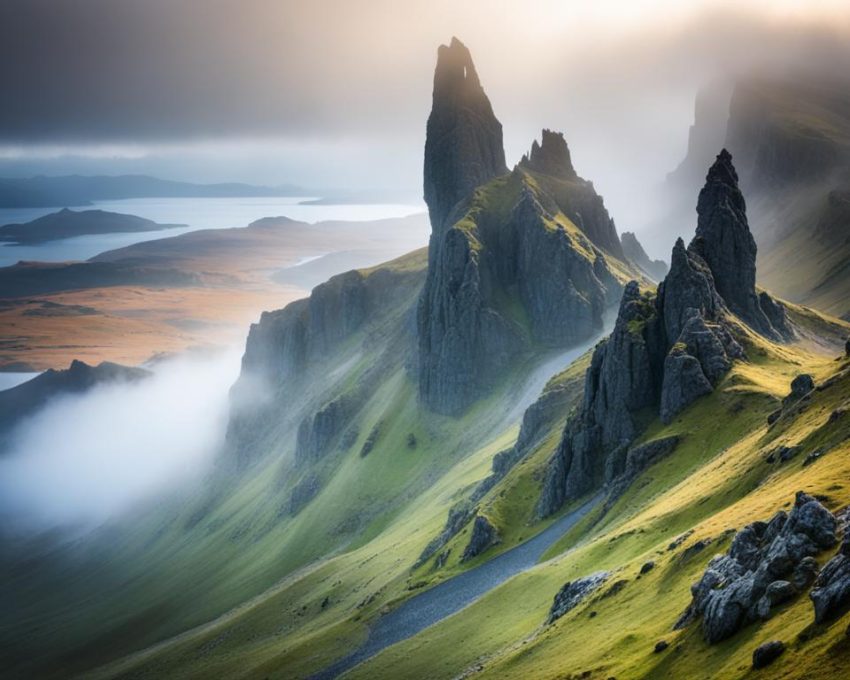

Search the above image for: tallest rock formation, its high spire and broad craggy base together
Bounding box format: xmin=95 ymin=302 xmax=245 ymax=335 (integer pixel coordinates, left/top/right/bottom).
xmin=417 ymin=46 xmax=622 ymax=414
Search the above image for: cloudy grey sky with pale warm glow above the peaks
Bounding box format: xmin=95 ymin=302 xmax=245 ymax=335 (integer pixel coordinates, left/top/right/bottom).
xmin=0 ymin=0 xmax=850 ymax=230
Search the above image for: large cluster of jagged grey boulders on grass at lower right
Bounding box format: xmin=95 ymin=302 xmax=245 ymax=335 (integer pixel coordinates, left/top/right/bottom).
xmin=676 ymin=491 xmax=837 ymax=644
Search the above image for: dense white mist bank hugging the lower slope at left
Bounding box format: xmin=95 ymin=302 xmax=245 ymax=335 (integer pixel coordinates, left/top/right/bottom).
xmin=0 ymin=347 xmax=241 ymax=531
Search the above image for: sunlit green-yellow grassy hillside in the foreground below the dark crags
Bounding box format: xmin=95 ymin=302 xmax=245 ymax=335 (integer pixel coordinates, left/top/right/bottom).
xmin=63 ymin=308 xmax=850 ymax=678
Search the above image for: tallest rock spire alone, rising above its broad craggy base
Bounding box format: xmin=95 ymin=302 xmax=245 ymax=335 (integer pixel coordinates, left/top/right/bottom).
xmin=425 ymin=38 xmax=508 ymax=233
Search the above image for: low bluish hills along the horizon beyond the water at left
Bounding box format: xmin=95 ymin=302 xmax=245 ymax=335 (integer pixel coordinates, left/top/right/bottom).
xmin=0 ymin=175 xmax=308 ymax=208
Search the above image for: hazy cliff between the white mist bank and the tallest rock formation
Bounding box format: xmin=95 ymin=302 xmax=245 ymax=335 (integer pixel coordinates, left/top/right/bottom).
xmin=227 ymin=251 xmax=425 ymax=464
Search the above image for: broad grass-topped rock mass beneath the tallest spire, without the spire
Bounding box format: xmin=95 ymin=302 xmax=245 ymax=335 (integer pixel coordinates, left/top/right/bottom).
xmin=418 ymin=169 xmax=620 ymax=414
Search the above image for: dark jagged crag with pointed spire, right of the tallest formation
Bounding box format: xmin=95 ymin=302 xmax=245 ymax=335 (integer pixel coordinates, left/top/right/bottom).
xmin=538 ymin=150 xmax=790 ymax=516
